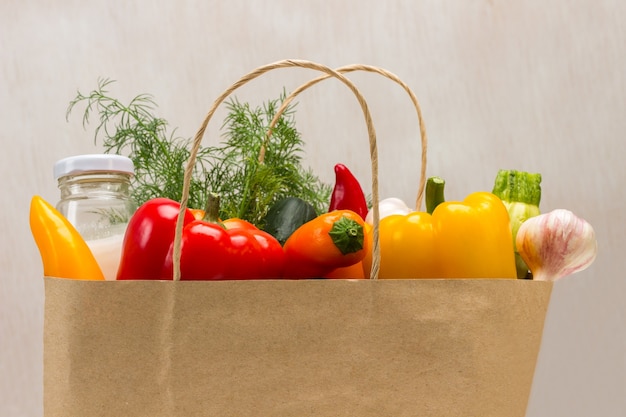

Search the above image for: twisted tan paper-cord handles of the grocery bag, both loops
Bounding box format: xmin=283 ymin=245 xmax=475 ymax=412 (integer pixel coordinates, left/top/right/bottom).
xmin=173 ymin=59 xmax=427 ymax=281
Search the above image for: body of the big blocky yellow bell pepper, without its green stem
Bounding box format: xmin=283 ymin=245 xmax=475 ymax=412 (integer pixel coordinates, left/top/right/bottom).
xmin=379 ymin=192 xmax=517 ymax=279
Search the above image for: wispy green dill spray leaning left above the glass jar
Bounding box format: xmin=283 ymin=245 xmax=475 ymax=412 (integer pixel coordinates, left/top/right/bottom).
xmin=66 ymin=79 xmax=209 ymax=208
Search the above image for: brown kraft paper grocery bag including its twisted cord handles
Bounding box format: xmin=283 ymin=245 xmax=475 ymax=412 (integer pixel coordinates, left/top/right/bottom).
xmin=44 ymin=60 xmax=552 ymax=417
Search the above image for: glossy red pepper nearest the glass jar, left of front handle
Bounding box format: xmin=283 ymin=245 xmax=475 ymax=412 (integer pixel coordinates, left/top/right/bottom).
xmin=117 ymin=198 xmax=194 ymax=280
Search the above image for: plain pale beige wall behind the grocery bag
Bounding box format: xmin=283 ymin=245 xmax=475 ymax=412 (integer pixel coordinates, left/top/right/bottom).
xmin=0 ymin=0 xmax=626 ymax=417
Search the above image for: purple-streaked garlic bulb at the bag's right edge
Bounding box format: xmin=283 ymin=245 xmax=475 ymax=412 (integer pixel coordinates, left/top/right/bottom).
xmin=516 ymin=209 xmax=598 ymax=281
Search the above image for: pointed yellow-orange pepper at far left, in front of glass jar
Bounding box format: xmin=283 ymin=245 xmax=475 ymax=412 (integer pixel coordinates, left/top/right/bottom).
xmin=30 ymin=196 xmax=104 ymax=280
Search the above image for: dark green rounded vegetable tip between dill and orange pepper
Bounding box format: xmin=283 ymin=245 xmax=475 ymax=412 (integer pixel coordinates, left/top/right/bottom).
xmin=263 ymin=197 xmax=317 ymax=245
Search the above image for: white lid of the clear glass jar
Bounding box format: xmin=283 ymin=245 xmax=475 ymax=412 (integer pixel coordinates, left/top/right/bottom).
xmin=54 ymin=154 xmax=135 ymax=180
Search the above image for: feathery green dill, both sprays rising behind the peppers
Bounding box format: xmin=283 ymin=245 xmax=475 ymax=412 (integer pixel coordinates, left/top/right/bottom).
xmin=66 ymin=79 xmax=332 ymax=227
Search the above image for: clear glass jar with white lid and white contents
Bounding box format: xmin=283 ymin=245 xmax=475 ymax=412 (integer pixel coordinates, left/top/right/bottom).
xmin=54 ymin=154 xmax=136 ymax=280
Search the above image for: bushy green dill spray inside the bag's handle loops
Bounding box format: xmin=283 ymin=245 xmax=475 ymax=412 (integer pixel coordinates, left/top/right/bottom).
xmin=208 ymin=93 xmax=332 ymax=227
